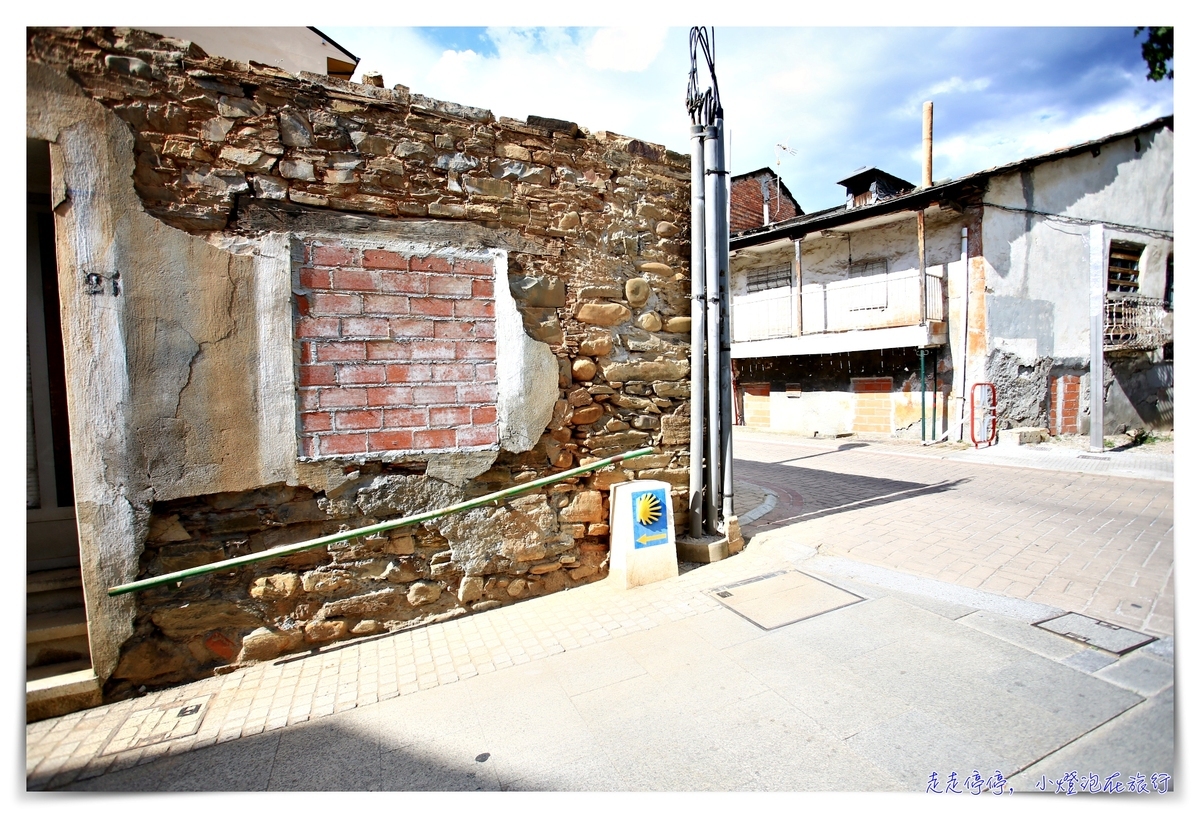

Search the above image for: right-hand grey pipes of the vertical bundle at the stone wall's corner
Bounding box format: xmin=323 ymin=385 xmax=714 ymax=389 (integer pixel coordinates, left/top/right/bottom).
xmin=704 ymin=119 xmax=724 ymax=527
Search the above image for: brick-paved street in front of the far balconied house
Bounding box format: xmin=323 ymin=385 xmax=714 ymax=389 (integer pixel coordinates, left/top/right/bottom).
xmin=734 ymin=432 xmax=1175 ymax=636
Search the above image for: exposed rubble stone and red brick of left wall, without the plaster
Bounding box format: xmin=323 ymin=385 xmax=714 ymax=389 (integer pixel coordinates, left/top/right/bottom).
xmin=26 ymin=28 xmax=690 ymax=698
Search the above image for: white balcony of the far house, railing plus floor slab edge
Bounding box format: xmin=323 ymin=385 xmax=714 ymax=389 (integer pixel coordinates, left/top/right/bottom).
xmin=732 ymin=270 xmax=946 ymax=357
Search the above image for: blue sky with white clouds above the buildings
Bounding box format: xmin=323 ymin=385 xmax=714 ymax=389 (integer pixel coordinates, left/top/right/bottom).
xmin=319 ymin=24 xmax=1175 ymax=211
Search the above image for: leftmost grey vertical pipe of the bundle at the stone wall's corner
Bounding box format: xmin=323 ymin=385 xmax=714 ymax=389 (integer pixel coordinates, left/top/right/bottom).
xmin=688 ymin=125 xmax=707 ymax=537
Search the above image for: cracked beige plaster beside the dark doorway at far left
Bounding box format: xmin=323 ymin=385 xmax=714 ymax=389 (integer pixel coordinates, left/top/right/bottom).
xmin=26 ymin=64 xmax=268 ymax=678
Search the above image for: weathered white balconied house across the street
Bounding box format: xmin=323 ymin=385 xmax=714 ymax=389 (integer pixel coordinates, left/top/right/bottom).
xmin=731 ymin=116 xmax=1174 ymax=440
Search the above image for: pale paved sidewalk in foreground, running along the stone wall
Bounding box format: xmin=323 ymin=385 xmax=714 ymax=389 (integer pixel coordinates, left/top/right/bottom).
xmin=26 ymin=529 xmax=1174 ymax=798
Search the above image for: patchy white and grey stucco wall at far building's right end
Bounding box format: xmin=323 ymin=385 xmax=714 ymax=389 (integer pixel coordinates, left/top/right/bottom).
xmin=983 ymin=127 xmax=1174 ymax=433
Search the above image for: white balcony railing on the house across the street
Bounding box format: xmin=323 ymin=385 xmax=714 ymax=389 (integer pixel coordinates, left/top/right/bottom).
xmin=732 ymin=270 xmax=946 ymax=343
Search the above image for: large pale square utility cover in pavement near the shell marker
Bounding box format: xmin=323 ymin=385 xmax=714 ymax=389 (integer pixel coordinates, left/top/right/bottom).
xmin=708 ymin=570 xmax=863 ymax=631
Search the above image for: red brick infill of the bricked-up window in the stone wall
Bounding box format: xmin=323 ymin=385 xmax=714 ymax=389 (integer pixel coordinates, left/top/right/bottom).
xmin=294 ymin=240 xmax=499 ymax=458
